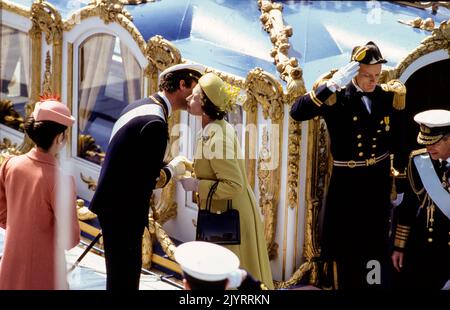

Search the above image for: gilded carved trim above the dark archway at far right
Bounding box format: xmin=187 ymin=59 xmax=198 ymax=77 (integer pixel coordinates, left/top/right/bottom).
xmin=393 ymin=20 xmax=450 ymax=78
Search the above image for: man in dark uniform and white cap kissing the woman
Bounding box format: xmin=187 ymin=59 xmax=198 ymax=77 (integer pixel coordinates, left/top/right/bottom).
xmin=90 ymin=64 xmax=204 ymax=290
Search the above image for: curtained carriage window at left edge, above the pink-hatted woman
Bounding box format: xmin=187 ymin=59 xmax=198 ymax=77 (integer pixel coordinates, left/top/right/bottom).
xmin=0 ymin=25 xmax=30 ymax=131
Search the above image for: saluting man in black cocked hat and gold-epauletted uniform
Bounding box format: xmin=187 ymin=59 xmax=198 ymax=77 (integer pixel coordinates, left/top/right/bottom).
xmin=290 ymin=42 xmax=407 ymax=289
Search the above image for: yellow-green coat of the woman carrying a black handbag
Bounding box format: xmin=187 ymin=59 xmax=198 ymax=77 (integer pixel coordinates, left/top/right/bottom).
xmin=194 ymin=120 xmax=274 ymax=289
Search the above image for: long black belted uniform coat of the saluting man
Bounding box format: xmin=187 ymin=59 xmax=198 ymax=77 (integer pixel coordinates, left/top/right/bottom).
xmin=290 ymin=82 xmax=407 ymax=266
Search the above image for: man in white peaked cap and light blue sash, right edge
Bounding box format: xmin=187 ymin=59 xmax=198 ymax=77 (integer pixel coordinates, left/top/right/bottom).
xmin=392 ymin=110 xmax=450 ymax=289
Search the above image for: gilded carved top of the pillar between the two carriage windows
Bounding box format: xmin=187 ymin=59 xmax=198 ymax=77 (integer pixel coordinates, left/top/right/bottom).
xmin=30 ymin=0 xmax=63 ymax=45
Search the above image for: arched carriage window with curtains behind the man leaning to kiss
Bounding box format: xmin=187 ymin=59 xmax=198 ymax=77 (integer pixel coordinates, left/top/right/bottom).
xmin=78 ymin=34 xmax=143 ymax=165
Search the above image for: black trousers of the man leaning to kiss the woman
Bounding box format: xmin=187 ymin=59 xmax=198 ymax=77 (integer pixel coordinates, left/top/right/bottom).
xmin=98 ymin=215 xmax=145 ymax=290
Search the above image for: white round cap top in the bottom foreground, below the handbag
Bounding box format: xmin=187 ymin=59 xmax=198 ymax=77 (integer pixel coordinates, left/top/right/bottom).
xmin=174 ymin=241 xmax=239 ymax=281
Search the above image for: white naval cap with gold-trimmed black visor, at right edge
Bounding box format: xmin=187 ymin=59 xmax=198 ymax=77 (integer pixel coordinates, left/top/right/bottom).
xmin=414 ymin=109 xmax=450 ymax=145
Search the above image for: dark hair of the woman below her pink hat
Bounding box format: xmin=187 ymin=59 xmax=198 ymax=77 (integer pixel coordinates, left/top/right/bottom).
xmin=24 ymin=116 xmax=67 ymax=151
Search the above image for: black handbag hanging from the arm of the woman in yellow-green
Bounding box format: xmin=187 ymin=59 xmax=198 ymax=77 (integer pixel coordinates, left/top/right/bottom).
xmin=195 ymin=181 xmax=241 ymax=244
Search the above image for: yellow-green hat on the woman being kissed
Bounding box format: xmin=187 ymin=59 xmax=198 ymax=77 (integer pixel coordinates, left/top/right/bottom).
xmin=198 ymin=72 xmax=239 ymax=112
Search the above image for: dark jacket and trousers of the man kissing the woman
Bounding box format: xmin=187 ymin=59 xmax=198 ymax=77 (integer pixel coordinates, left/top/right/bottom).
xmin=89 ymin=94 xmax=168 ymax=289
